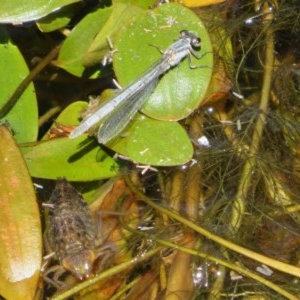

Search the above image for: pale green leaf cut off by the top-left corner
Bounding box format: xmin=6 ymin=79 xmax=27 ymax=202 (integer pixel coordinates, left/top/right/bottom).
xmin=0 ymin=0 xmax=80 ymax=24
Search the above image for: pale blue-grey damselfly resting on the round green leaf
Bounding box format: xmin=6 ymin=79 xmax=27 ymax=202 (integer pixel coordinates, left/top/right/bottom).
xmin=70 ymin=30 xmax=201 ymax=144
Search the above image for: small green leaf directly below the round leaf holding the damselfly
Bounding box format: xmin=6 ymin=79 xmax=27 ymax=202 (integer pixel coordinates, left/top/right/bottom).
xmin=109 ymin=114 xmax=193 ymax=166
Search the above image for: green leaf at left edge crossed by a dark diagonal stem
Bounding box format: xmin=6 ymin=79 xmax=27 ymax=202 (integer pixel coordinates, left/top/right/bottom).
xmin=0 ymin=26 xmax=38 ymax=143
